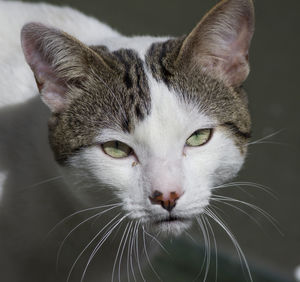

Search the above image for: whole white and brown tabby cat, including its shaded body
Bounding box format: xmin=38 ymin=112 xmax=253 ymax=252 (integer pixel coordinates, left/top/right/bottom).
xmin=0 ymin=0 xmax=254 ymax=282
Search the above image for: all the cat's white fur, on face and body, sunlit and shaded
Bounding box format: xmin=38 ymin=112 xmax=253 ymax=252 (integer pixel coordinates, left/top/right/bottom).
xmin=0 ymin=1 xmax=243 ymax=282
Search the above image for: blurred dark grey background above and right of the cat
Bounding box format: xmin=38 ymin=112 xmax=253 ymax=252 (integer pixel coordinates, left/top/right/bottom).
xmin=16 ymin=0 xmax=300 ymax=281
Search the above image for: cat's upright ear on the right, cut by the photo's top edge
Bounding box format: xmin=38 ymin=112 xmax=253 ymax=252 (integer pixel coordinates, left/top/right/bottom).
xmin=177 ymin=0 xmax=254 ymax=87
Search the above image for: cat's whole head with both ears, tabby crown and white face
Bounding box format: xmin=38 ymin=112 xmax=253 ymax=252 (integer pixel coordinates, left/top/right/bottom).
xmin=22 ymin=0 xmax=254 ymax=233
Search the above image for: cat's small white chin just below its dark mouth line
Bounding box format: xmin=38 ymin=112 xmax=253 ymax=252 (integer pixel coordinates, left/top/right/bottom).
xmin=152 ymin=217 xmax=192 ymax=236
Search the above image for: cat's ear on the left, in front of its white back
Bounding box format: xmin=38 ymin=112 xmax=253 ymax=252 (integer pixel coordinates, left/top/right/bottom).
xmin=21 ymin=23 xmax=109 ymax=113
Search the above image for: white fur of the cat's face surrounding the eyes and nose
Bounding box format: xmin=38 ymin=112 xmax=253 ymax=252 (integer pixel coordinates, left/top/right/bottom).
xmin=64 ymin=79 xmax=246 ymax=235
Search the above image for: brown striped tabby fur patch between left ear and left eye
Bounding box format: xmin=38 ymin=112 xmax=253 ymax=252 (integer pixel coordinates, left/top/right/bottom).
xmin=49 ymin=47 xmax=151 ymax=163
